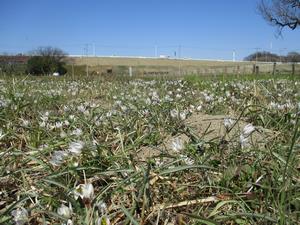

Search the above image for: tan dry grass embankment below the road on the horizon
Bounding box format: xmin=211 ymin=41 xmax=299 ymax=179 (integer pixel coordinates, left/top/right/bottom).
xmin=68 ymin=57 xmax=300 ymax=75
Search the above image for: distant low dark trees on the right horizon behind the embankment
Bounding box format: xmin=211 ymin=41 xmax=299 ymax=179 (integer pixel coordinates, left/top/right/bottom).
xmin=244 ymin=51 xmax=300 ymax=62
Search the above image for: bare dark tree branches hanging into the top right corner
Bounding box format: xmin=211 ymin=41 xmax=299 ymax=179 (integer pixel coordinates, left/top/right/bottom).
xmin=258 ymin=0 xmax=300 ymax=33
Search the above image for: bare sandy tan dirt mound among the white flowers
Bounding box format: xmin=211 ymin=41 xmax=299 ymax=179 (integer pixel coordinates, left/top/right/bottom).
xmin=137 ymin=113 xmax=278 ymax=161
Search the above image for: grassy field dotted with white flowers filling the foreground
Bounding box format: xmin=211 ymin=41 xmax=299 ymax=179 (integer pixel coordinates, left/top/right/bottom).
xmin=0 ymin=74 xmax=300 ymax=225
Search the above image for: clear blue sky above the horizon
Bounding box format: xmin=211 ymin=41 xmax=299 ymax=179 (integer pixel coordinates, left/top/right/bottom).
xmin=0 ymin=0 xmax=300 ymax=59
